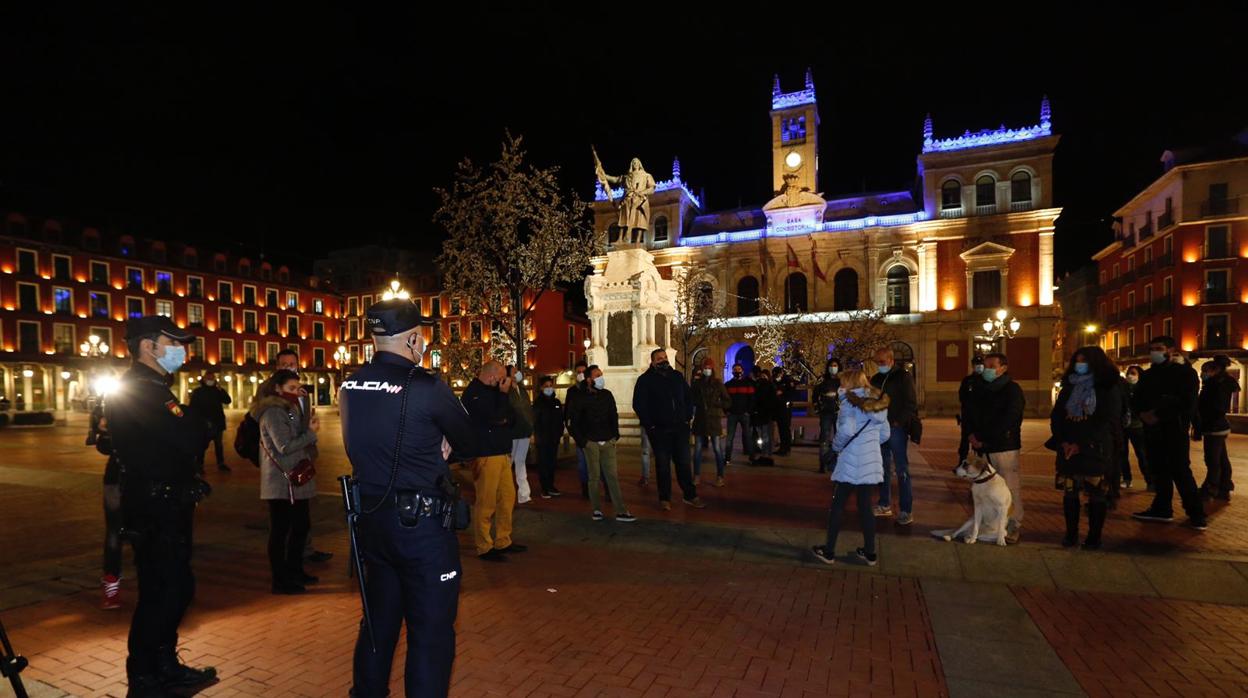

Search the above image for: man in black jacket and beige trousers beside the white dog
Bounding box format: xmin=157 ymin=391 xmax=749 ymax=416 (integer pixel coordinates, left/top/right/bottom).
xmin=968 ymin=352 xmax=1027 ymax=543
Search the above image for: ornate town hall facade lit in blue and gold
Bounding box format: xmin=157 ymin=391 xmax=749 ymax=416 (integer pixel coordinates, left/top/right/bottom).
xmin=590 ymin=72 xmax=1061 ymax=415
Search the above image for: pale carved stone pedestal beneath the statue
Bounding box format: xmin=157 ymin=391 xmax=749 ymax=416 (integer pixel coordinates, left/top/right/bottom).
xmin=585 ymin=247 xmax=676 ymax=443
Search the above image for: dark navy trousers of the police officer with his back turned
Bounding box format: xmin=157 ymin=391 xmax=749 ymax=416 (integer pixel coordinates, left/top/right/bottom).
xmin=353 ymin=508 xmax=463 ymax=698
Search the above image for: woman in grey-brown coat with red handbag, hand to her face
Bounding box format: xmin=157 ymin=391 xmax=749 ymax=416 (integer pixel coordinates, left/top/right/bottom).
xmin=251 ymin=370 xmax=321 ymax=594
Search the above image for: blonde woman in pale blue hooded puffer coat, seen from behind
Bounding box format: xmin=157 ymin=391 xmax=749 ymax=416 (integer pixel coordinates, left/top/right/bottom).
xmin=810 ymin=370 xmax=889 ymax=566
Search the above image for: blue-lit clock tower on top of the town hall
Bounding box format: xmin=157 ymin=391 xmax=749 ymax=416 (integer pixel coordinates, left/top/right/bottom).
xmin=771 ymin=69 xmax=819 ymax=194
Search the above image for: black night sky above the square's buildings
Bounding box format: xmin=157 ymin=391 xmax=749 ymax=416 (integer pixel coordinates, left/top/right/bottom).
xmin=0 ymin=2 xmax=1248 ymax=278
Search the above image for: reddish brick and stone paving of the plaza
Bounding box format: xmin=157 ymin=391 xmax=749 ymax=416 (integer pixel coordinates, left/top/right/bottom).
xmin=0 ymin=412 xmax=1248 ymax=698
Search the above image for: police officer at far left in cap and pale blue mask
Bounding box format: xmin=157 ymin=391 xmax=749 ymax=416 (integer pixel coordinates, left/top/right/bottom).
xmin=105 ymin=316 xmax=217 ymax=698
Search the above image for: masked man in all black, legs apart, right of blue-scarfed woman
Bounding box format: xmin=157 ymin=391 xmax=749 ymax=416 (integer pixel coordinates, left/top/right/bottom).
xmin=1131 ymin=336 xmax=1208 ymax=531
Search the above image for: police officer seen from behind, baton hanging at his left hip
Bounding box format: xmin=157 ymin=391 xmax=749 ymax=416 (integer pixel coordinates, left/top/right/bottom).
xmin=338 ymin=298 xmax=473 ymax=698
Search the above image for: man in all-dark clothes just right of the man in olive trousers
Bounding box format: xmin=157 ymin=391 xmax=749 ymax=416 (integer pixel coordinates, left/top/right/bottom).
xmin=633 ymin=348 xmax=706 ymax=511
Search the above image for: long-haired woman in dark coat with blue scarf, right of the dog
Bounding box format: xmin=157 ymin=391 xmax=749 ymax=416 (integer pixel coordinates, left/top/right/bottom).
xmin=1045 ymin=347 xmax=1123 ymax=549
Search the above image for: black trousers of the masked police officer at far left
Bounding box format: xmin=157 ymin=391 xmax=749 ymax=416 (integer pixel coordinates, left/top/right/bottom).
xmin=125 ymin=497 xmax=195 ymax=678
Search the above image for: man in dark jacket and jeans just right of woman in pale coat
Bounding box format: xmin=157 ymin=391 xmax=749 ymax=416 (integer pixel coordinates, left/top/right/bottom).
xmin=871 ymin=348 xmax=919 ymax=526
